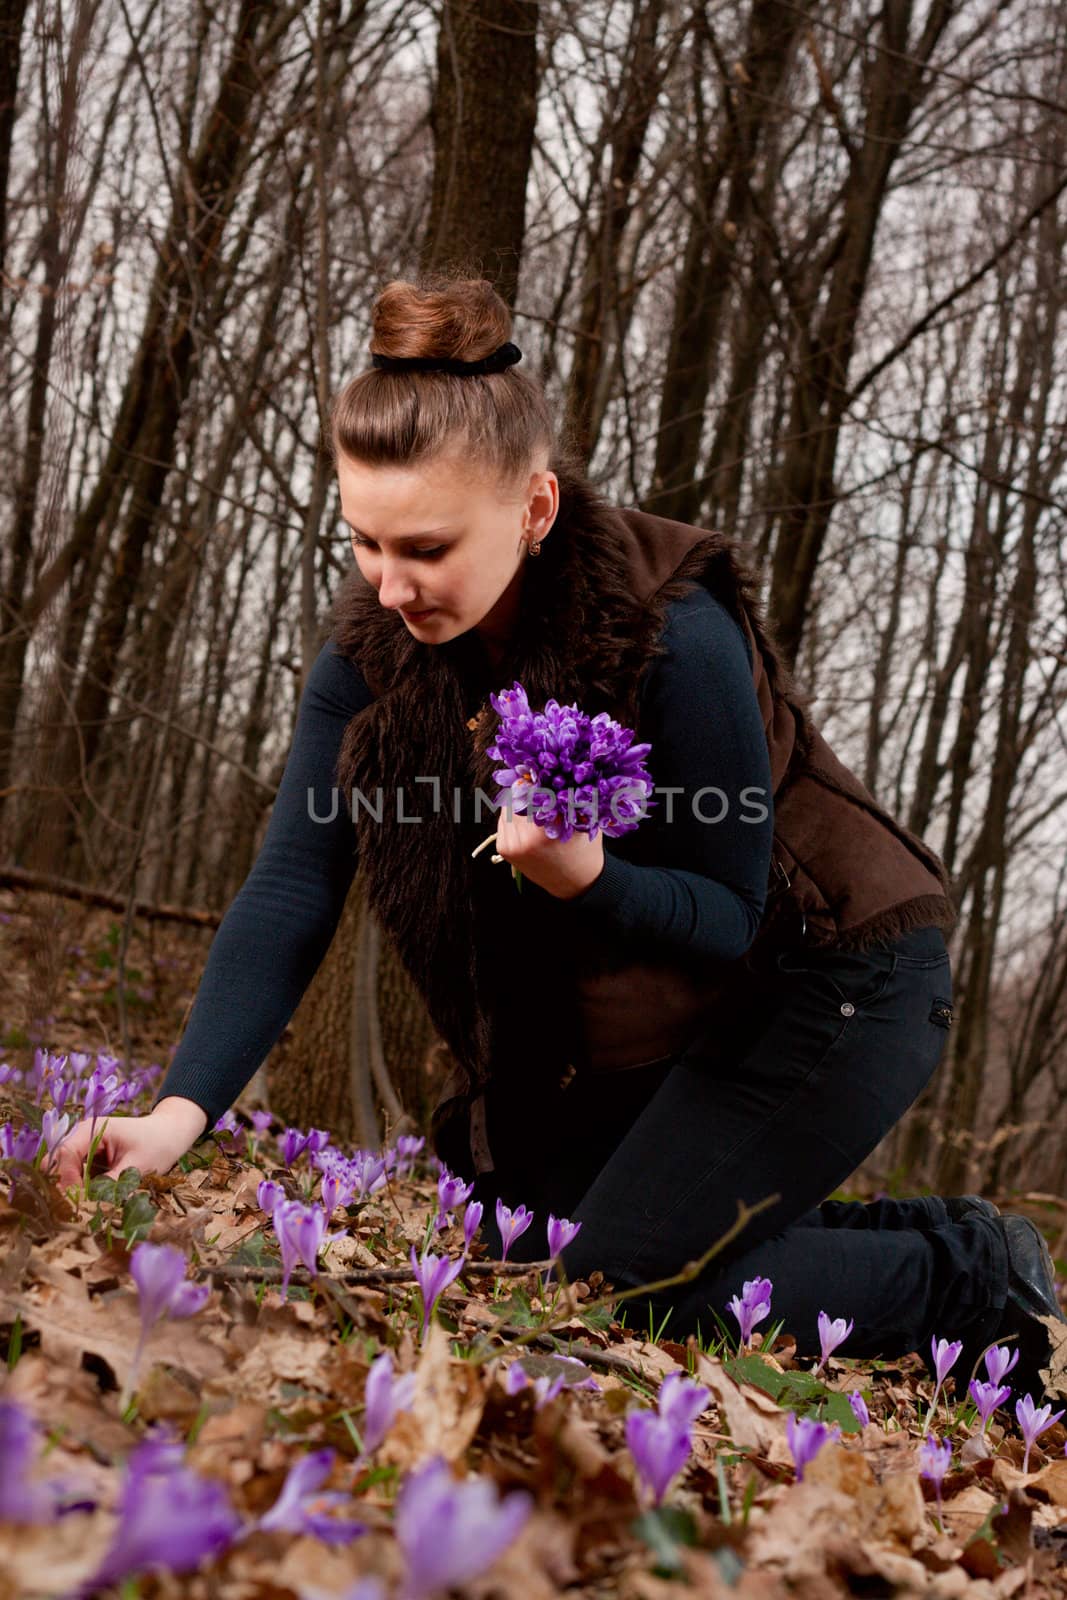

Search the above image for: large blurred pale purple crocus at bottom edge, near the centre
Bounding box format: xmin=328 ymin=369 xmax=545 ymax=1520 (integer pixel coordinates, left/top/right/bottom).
xmin=394 ymin=1456 xmax=533 ymax=1600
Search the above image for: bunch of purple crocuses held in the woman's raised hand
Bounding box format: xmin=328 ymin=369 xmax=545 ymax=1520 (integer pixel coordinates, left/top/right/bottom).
xmin=472 ymin=668 xmax=657 ymax=883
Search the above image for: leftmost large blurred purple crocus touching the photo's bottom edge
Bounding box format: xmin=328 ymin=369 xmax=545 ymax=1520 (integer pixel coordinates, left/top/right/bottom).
xmin=75 ymin=1437 xmax=240 ymax=1600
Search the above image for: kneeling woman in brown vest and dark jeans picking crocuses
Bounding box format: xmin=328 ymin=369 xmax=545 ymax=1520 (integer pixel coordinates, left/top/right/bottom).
xmin=56 ymin=278 xmax=1059 ymax=1395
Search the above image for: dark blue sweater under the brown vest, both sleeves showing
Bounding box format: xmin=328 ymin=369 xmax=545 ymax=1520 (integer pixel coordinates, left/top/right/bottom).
xmin=154 ymin=589 xmax=773 ymax=1128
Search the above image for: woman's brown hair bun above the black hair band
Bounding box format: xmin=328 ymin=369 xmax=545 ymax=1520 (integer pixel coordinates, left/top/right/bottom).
xmin=371 ymin=272 xmax=512 ymax=362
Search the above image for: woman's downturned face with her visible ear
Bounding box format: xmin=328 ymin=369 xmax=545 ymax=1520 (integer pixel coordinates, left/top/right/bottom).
xmin=338 ymin=456 xmax=560 ymax=650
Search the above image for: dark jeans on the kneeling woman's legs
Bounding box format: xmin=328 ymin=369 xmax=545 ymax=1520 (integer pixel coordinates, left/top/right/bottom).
xmin=475 ymin=928 xmax=1008 ymax=1357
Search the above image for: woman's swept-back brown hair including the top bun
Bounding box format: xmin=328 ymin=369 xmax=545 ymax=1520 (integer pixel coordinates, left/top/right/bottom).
xmin=330 ymin=272 xmax=557 ymax=483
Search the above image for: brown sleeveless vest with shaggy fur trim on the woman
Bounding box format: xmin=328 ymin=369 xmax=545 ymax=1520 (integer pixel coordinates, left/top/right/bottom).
xmin=330 ymin=469 xmax=955 ymax=1170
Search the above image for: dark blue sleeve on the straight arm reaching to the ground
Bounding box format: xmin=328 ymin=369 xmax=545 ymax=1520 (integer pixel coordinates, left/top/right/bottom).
xmin=152 ymin=640 xmax=371 ymax=1128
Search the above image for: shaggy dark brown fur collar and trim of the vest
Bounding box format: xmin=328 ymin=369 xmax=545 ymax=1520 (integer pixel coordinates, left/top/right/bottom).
xmin=330 ymin=467 xmax=783 ymax=1085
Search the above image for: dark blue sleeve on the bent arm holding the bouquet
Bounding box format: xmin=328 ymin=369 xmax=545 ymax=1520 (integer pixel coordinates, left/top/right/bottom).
xmin=561 ymin=589 xmax=774 ymax=962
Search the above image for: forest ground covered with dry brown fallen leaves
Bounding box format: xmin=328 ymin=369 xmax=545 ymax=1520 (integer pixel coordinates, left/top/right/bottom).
xmin=0 ymin=891 xmax=1067 ymax=1600
